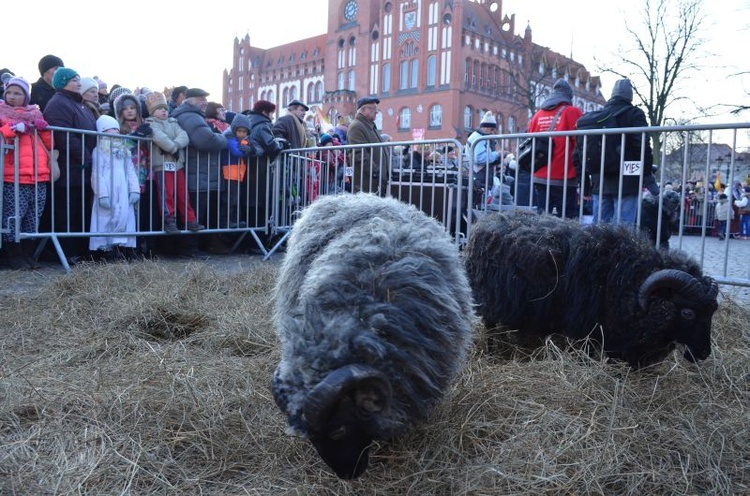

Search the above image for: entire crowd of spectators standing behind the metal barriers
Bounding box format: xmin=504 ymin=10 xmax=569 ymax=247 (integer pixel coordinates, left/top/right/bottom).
xmin=0 ymin=55 xmax=750 ymax=269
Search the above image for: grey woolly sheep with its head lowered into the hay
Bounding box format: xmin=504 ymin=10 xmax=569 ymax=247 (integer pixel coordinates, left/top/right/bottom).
xmin=272 ymin=194 xmax=474 ymax=479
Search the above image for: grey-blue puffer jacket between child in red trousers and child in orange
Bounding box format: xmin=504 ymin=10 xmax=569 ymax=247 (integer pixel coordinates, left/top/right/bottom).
xmin=172 ymin=102 xmax=227 ymax=193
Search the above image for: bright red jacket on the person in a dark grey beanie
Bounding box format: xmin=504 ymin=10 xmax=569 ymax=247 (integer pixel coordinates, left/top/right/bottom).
xmin=528 ymin=103 xmax=583 ymax=181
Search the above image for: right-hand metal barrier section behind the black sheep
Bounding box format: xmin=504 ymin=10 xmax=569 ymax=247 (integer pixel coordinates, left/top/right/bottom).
xmin=466 ymin=123 xmax=750 ymax=286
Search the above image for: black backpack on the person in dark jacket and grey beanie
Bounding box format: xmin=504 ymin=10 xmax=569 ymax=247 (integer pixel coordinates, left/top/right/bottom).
xmin=576 ymin=107 xmax=631 ymax=176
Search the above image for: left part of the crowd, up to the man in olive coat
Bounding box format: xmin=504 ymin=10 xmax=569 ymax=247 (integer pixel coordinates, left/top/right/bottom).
xmin=0 ymin=55 xmax=408 ymax=269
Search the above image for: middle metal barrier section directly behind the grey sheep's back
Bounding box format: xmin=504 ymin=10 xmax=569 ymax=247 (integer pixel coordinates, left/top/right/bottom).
xmin=266 ymin=140 xmax=466 ymax=258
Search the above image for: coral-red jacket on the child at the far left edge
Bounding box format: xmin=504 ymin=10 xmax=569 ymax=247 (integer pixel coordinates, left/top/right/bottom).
xmin=0 ymin=121 xmax=52 ymax=184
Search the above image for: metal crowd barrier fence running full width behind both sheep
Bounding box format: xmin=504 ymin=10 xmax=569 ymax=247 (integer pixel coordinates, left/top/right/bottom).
xmin=0 ymin=124 xmax=750 ymax=285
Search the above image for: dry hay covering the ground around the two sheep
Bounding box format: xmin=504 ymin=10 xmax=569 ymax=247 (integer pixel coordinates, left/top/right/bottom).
xmin=0 ymin=262 xmax=750 ymax=495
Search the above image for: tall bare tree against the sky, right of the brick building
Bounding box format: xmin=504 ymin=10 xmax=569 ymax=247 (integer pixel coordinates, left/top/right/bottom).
xmin=606 ymin=0 xmax=705 ymax=157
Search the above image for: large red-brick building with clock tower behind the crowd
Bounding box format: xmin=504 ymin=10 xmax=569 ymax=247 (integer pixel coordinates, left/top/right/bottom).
xmin=223 ymin=0 xmax=605 ymax=141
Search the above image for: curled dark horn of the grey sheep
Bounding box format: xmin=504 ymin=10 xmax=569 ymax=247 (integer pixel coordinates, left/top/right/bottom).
xmin=304 ymin=365 xmax=393 ymax=430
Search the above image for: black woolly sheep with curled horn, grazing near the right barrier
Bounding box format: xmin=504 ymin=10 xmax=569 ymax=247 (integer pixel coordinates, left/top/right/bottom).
xmin=466 ymin=210 xmax=718 ymax=367
